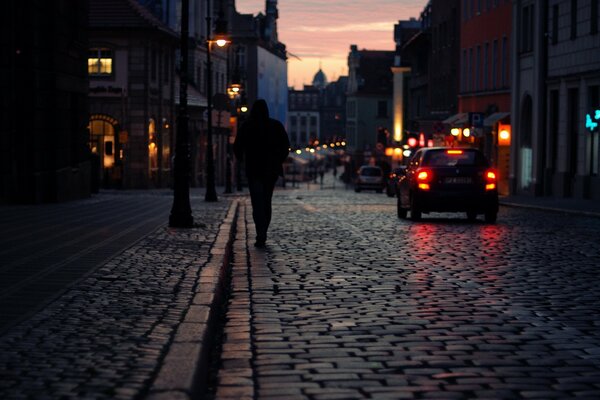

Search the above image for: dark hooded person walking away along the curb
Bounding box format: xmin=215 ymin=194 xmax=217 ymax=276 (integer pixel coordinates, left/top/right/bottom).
xmin=233 ymin=99 xmax=290 ymax=247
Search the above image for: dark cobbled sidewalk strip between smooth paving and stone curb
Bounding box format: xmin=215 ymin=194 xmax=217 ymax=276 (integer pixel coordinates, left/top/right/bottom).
xmin=0 ymin=192 xmax=231 ymax=399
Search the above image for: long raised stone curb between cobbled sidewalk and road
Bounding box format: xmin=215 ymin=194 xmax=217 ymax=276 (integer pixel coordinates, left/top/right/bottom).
xmin=146 ymin=200 xmax=239 ymax=400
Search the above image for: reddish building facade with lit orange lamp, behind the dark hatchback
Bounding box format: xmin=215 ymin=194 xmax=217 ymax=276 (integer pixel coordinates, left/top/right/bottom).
xmin=460 ymin=1 xmax=512 ymax=194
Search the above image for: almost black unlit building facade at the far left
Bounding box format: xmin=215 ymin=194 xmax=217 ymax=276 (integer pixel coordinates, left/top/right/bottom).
xmin=0 ymin=0 xmax=91 ymax=203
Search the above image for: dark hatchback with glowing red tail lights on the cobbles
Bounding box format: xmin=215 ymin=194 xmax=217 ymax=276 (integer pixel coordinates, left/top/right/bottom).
xmin=397 ymin=147 xmax=498 ymax=223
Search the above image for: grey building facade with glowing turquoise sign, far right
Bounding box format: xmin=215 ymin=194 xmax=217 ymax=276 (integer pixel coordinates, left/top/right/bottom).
xmin=511 ymin=0 xmax=600 ymax=201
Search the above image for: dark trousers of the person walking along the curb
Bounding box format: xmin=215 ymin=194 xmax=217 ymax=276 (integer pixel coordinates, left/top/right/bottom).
xmin=248 ymin=176 xmax=277 ymax=241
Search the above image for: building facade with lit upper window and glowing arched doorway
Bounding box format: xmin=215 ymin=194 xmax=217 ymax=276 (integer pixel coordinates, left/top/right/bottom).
xmin=88 ymin=0 xmax=178 ymax=188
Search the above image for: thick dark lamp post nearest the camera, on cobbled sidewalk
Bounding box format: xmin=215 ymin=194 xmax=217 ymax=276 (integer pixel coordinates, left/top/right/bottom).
xmin=169 ymin=0 xmax=194 ymax=228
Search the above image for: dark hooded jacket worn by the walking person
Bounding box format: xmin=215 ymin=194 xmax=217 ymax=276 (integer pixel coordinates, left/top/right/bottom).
xmin=233 ymin=99 xmax=290 ymax=178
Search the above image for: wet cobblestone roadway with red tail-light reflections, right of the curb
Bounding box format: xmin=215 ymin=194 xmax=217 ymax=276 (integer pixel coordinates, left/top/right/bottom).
xmin=216 ymin=185 xmax=600 ymax=399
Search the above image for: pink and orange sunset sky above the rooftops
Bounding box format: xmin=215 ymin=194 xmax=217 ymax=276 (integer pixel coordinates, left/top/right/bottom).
xmin=236 ymin=0 xmax=427 ymax=89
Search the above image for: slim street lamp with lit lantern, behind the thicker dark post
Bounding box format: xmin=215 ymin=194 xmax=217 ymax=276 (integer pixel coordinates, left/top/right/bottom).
xmin=204 ymin=0 xmax=229 ymax=201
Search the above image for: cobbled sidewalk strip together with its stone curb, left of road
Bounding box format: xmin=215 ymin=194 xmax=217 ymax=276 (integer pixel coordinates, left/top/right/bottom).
xmin=0 ymin=191 xmax=238 ymax=399
